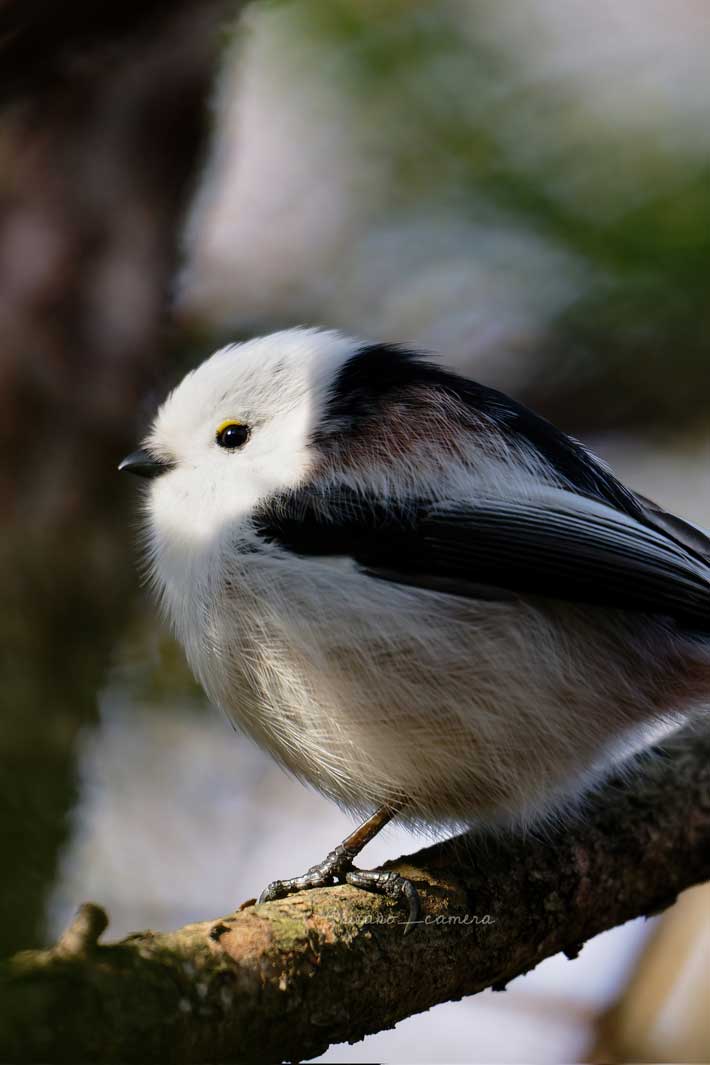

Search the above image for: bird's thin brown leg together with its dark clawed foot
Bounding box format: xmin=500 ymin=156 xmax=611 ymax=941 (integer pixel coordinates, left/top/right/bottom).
xmin=259 ymin=803 xmax=419 ymax=933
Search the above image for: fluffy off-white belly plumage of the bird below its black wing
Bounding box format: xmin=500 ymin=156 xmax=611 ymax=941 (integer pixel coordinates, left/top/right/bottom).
xmin=172 ymin=551 xmax=709 ymax=824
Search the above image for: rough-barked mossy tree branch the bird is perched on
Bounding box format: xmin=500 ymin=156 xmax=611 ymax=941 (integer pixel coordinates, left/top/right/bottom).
xmin=0 ymin=733 xmax=710 ymax=1063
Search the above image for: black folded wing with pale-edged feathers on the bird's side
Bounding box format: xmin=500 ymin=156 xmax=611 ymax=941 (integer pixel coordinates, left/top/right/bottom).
xmin=260 ymin=487 xmax=710 ymax=630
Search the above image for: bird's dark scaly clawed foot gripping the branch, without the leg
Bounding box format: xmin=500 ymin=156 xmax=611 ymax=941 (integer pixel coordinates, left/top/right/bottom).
xmin=259 ymin=856 xmax=420 ymax=935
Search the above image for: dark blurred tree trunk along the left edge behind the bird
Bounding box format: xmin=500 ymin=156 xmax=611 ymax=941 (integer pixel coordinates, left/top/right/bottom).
xmin=0 ymin=0 xmax=238 ymax=953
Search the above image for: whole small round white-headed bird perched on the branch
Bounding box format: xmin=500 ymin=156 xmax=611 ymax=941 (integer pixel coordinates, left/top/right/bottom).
xmin=119 ymin=329 xmax=710 ymax=928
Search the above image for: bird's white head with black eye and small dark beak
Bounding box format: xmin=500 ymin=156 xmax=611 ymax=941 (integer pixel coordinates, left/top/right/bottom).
xmin=121 ymin=329 xmax=376 ymax=609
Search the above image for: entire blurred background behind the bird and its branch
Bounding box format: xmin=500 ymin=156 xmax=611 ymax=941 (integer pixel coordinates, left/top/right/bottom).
xmin=0 ymin=0 xmax=710 ymax=1063
